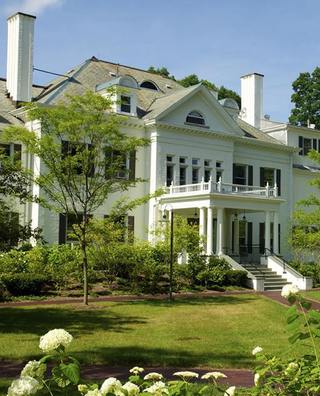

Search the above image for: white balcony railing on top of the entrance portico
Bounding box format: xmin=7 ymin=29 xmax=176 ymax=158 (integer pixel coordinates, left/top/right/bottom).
xmin=165 ymin=179 xmax=278 ymax=198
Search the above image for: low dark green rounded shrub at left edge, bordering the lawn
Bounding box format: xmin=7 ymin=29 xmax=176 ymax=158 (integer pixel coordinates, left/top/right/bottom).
xmin=1 ymin=273 xmax=49 ymax=296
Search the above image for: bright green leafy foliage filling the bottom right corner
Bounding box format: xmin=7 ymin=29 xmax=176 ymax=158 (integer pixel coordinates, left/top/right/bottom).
xmin=251 ymin=293 xmax=320 ymax=396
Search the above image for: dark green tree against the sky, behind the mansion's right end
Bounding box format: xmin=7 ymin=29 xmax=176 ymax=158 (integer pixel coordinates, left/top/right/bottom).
xmin=289 ymin=67 xmax=320 ymax=129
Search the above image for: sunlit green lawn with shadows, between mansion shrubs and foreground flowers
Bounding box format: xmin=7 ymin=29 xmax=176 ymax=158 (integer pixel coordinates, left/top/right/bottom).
xmin=0 ymin=294 xmax=310 ymax=368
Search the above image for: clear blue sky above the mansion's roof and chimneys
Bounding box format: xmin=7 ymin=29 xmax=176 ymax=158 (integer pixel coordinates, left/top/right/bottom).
xmin=0 ymin=0 xmax=320 ymax=121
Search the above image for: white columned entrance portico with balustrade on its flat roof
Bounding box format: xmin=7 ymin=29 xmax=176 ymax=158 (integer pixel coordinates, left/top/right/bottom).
xmin=157 ymin=182 xmax=284 ymax=255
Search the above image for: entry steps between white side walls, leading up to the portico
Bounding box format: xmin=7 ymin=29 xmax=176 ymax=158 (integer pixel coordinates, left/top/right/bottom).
xmin=241 ymin=263 xmax=290 ymax=291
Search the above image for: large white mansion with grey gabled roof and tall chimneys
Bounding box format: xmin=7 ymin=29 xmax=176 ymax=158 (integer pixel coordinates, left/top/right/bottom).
xmin=0 ymin=13 xmax=320 ymax=290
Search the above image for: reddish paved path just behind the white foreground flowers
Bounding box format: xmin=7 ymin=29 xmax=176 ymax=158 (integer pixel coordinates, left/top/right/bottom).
xmin=0 ymin=362 xmax=253 ymax=387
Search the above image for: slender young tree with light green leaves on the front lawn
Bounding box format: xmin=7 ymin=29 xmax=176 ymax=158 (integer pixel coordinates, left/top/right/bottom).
xmin=5 ymin=92 xmax=148 ymax=304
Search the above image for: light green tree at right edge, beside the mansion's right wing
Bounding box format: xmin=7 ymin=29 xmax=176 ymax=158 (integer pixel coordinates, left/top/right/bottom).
xmin=291 ymin=150 xmax=320 ymax=256
